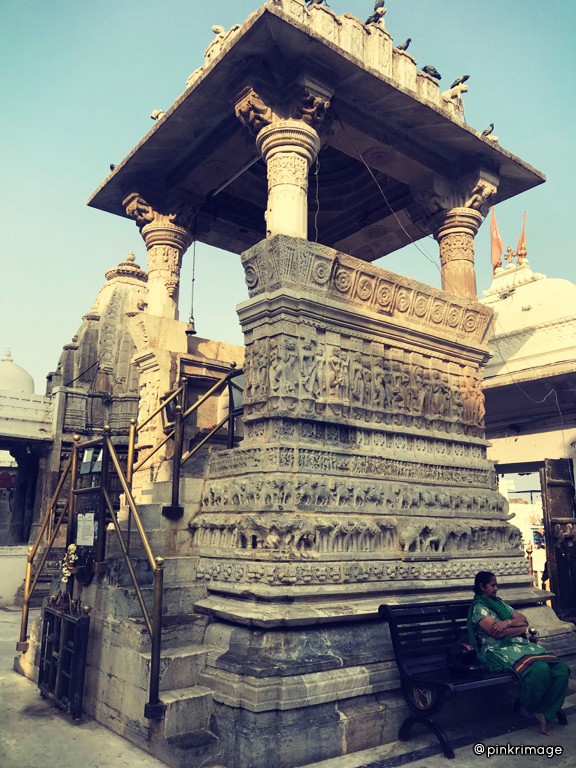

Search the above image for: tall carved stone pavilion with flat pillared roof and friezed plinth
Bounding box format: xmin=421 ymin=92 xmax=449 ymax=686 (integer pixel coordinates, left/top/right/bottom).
xmin=14 ymin=0 xmax=575 ymax=768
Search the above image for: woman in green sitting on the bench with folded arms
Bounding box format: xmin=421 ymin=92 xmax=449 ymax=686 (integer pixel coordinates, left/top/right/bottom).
xmin=468 ymin=571 xmax=570 ymax=736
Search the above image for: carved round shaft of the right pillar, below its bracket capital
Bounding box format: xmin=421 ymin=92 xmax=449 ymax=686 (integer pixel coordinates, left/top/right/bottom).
xmin=434 ymin=208 xmax=482 ymax=301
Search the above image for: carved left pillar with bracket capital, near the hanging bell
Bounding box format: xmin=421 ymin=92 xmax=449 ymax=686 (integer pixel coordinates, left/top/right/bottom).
xmin=123 ymin=198 xmax=192 ymax=320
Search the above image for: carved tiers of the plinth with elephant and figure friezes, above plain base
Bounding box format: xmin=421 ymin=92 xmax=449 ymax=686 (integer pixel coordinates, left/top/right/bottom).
xmin=190 ymin=237 xmax=526 ymax=616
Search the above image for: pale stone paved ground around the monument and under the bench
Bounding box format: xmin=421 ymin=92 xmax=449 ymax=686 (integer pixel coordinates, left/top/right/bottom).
xmin=0 ymin=607 xmax=576 ymax=768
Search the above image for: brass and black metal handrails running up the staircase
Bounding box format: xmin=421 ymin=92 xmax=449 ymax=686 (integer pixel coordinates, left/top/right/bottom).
xmin=16 ymin=368 xmax=243 ymax=720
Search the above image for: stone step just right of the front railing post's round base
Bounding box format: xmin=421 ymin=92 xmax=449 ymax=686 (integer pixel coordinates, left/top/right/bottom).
xmin=160 ymin=685 xmax=213 ymax=739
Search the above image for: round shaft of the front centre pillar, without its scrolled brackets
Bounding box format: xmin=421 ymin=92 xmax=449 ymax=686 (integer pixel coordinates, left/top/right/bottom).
xmin=257 ymin=119 xmax=320 ymax=238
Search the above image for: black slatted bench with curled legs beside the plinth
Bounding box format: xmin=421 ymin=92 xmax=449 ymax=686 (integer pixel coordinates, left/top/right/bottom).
xmin=378 ymin=602 xmax=566 ymax=759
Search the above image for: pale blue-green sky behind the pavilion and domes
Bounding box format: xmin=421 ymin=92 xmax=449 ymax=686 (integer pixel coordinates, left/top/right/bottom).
xmin=0 ymin=0 xmax=576 ymax=394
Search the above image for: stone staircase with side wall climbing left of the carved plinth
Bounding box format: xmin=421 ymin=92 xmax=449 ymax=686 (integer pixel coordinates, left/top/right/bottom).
xmin=86 ymin=478 xmax=219 ymax=768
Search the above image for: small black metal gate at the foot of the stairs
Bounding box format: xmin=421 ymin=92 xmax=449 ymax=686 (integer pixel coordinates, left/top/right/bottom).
xmin=38 ymin=592 xmax=90 ymax=720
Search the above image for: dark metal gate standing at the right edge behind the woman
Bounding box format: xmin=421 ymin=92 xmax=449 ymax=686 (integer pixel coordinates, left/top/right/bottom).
xmin=540 ymin=459 xmax=576 ymax=622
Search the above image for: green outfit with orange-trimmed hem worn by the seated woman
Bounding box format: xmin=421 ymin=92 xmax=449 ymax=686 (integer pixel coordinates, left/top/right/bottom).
xmin=468 ymin=595 xmax=570 ymax=720
